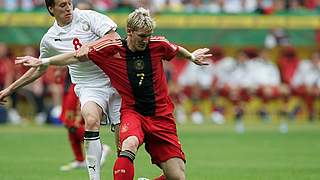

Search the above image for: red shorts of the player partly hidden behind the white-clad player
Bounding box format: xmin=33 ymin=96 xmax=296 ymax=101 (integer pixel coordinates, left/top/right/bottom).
xmin=60 ymin=84 xmax=84 ymax=127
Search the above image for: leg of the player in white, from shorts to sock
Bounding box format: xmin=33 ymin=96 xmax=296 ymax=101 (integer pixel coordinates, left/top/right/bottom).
xmin=75 ymin=85 xmax=120 ymax=179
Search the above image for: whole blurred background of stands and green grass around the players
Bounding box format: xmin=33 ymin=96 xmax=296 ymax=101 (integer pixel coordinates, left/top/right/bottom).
xmin=0 ymin=0 xmax=320 ymax=180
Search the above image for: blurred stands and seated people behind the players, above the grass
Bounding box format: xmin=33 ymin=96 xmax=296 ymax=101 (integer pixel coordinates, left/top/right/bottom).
xmin=0 ymin=0 xmax=320 ymax=133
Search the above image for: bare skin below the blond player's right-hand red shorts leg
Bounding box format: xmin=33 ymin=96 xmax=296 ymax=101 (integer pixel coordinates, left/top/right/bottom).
xmin=160 ymin=157 xmax=185 ymax=180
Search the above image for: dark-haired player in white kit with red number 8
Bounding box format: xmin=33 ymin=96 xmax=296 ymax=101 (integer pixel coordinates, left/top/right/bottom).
xmin=0 ymin=0 xmax=121 ymax=180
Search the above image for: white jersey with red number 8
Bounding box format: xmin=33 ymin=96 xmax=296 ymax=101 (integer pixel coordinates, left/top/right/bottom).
xmin=40 ymin=9 xmax=117 ymax=87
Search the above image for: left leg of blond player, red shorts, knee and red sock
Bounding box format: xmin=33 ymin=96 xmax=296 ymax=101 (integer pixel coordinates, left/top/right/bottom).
xmin=113 ymin=111 xmax=144 ymax=180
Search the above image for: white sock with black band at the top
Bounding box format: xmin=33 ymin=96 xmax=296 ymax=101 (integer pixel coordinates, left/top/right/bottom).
xmin=84 ymin=131 xmax=102 ymax=180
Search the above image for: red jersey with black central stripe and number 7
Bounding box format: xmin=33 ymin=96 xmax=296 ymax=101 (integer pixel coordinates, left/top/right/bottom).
xmin=88 ymin=36 xmax=179 ymax=116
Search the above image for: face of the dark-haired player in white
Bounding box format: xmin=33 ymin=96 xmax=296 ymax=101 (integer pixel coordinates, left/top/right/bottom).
xmin=49 ymin=0 xmax=73 ymax=26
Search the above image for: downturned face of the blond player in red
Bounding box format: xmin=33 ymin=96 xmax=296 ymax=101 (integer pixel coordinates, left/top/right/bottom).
xmin=128 ymin=29 xmax=153 ymax=51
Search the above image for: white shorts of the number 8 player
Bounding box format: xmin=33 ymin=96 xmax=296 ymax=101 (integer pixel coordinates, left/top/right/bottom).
xmin=74 ymin=85 xmax=121 ymax=125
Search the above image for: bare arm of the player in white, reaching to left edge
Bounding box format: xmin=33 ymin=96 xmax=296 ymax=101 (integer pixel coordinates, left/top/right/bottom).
xmin=0 ymin=66 xmax=47 ymax=104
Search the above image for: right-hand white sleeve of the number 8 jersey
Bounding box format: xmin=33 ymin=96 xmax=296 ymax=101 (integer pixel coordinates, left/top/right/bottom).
xmin=86 ymin=10 xmax=117 ymax=37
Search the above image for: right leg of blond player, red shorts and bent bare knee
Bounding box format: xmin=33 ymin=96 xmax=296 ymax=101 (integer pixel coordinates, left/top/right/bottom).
xmin=142 ymin=115 xmax=185 ymax=180
